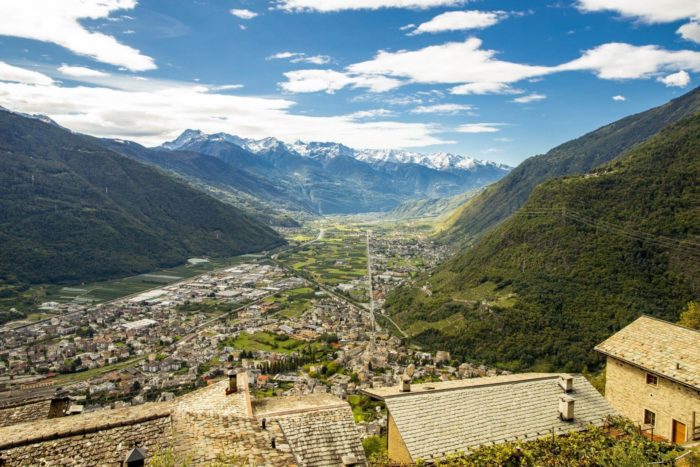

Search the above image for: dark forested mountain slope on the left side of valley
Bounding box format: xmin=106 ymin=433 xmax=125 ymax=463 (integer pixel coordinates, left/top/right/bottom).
xmin=0 ymin=110 xmax=283 ymax=283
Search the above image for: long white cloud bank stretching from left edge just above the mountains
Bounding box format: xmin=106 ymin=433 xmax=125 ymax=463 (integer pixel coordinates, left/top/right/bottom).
xmin=0 ymin=76 xmax=449 ymax=148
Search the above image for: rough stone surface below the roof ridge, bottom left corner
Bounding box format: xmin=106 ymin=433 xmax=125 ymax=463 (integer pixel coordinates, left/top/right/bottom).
xmin=0 ymin=416 xmax=172 ymax=466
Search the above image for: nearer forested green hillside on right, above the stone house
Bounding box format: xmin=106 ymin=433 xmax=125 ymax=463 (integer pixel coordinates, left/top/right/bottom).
xmin=387 ymin=115 xmax=700 ymax=371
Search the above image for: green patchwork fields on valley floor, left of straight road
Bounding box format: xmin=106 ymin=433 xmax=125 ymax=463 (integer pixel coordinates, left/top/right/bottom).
xmin=279 ymin=228 xmax=368 ymax=302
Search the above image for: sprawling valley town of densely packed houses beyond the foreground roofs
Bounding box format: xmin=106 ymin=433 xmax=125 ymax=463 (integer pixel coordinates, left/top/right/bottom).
xmin=0 ymin=229 xmax=478 ymax=426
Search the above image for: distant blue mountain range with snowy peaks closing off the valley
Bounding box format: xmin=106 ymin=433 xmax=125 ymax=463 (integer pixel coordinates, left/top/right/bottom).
xmin=148 ymin=130 xmax=510 ymax=214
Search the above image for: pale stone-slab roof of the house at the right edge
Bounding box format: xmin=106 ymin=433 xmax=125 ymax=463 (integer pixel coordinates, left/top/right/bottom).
xmin=595 ymin=316 xmax=700 ymax=389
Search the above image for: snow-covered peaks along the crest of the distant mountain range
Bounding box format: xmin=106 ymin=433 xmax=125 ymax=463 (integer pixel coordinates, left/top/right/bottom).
xmin=162 ymin=130 xmax=510 ymax=171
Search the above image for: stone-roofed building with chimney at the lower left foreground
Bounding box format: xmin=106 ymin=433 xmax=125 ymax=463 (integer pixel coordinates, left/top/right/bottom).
xmin=0 ymin=373 xmax=367 ymax=467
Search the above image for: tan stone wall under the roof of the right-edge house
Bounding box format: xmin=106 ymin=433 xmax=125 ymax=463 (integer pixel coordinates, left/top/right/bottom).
xmin=605 ymin=357 xmax=700 ymax=440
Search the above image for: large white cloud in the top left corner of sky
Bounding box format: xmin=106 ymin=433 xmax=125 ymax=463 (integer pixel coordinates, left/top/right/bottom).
xmin=0 ymin=0 xmax=156 ymax=71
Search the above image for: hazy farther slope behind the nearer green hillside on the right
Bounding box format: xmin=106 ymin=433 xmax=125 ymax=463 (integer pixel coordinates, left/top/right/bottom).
xmin=442 ymin=88 xmax=700 ymax=243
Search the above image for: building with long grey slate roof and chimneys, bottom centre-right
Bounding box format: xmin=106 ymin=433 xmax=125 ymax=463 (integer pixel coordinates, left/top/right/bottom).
xmin=363 ymin=373 xmax=615 ymax=464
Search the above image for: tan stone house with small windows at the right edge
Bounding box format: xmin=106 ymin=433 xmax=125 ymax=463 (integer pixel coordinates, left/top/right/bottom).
xmin=595 ymin=316 xmax=700 ymax=444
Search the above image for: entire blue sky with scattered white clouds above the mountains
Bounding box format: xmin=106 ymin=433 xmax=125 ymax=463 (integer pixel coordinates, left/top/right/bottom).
xmin=0 ymin=0 xmax=700 ymax=165
